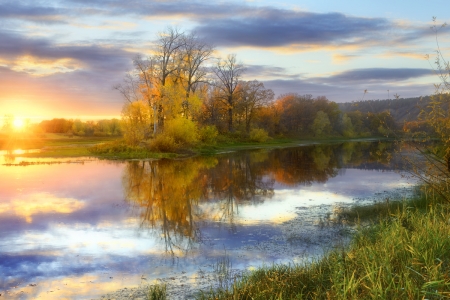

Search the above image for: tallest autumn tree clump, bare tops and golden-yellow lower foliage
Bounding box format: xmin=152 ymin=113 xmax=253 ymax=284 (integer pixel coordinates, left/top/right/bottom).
xmin=115 ymin=28 xmax=213 ymax=144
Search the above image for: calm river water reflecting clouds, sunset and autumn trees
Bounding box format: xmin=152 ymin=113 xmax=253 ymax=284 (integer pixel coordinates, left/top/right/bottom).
xmin=0 ymin=142 xmax=410 ymax=299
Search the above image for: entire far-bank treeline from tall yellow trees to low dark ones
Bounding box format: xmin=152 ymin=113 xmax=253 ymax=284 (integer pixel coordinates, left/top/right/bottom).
xmin=116 ymin=29 xmax=397 ymax=151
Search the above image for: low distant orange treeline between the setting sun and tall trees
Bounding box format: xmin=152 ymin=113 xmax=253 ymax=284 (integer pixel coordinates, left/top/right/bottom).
xmin=39 ymin=118 xmax=122 ymax=136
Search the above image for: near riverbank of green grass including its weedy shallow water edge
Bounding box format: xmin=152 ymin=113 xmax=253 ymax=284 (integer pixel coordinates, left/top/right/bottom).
xmin=90 ymin=190 xmax=450 ymax=300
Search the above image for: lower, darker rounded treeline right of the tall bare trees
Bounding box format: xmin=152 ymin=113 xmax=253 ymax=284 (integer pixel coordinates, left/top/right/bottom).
xmin=251 ymin=94 xmax=398 ymax=138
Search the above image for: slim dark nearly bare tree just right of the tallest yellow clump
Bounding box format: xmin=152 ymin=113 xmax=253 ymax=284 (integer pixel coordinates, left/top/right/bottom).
xmin=213 ymin=54 xmax=244 ymax=132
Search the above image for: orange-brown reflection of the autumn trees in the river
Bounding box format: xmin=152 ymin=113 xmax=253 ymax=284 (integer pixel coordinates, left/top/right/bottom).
xmin=123 ymin=143 xmax=400 ymax=254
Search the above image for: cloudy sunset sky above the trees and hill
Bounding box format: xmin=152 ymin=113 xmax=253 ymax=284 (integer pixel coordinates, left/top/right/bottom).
xmin=0 ymin=0 xmax=450 ymax=120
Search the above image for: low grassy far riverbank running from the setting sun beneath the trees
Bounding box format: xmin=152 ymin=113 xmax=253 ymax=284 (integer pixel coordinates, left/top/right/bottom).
xmin=0 ymin=134 xmax=393 ymax=160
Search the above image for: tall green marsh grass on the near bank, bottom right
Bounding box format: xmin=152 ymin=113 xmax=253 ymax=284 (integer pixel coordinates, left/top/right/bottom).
xmin=198 ymin=200 xmax=450 ymax=299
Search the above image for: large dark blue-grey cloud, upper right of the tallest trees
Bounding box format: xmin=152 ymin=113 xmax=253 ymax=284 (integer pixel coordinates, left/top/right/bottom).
xmin=195 ymin=8 xmax=392 ymax=47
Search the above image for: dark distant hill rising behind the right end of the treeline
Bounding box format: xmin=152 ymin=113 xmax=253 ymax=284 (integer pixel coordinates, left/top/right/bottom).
xmin=338 ymin=96 xmax=430 ymax=123
